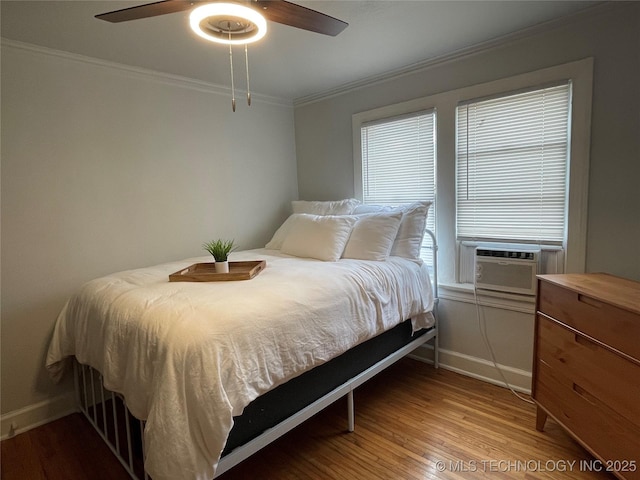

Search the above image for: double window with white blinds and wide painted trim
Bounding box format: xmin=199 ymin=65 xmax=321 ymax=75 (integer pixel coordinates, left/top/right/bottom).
xmin=352 ymin=58 xmax=593 ymax=288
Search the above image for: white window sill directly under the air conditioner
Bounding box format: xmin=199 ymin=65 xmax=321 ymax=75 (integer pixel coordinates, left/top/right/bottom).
xmin=438 ymin=282 xmax=536 ymax=314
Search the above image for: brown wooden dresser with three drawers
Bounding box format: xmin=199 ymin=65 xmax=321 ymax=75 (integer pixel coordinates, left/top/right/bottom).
xmin=532 ymin=273 xmax=640 ymax=480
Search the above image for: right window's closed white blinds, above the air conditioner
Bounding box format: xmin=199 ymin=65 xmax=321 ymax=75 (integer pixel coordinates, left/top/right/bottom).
xmin=456 ymin=83 xmax=571 ymax=245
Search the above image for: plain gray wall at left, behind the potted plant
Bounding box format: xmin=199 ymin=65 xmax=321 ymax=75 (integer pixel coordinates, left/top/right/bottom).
xmin=1 ymin=42 xmax=297 ymax=424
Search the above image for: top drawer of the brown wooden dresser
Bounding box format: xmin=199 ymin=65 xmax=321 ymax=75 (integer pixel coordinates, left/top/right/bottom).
xmin=538 ymin=281 xmax=640 ymax=359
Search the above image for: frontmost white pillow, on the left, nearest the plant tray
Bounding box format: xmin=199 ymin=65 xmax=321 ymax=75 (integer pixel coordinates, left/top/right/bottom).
xmin=280 ymin=213 xmax=357 ymax=262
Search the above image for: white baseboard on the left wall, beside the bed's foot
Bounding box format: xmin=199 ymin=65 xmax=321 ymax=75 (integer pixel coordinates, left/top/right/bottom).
xmin=0 ymin=391 xmax=78 ymax=440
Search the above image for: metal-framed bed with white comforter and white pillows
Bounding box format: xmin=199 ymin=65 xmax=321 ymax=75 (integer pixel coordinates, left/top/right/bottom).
xmin=47 ymin=202 xmax=437 ymax=480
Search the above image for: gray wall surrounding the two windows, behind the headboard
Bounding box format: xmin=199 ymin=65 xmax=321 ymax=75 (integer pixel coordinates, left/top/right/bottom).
xmin=295 ymin=2 xmax=640 ymax=390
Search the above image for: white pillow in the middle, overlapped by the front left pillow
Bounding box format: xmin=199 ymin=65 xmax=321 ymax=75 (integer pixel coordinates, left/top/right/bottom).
xmin=342 ymin=211 xmax=402 ymax=261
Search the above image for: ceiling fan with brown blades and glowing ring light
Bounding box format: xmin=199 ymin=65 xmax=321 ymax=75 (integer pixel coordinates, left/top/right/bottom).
xmin=96 ymin=0 xmax=349 ymax=112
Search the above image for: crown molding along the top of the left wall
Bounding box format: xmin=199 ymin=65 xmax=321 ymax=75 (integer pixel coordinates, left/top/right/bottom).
xmin=1 ymin=37 xmax=292 ymax=107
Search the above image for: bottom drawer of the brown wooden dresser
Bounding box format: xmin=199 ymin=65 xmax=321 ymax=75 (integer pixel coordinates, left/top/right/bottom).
xmin=535 ymin=360 xmax=640 ymax=480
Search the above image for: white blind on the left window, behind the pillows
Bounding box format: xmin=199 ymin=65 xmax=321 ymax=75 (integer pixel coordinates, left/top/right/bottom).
xmin=360 ymin=110 xmax=436 ymax=263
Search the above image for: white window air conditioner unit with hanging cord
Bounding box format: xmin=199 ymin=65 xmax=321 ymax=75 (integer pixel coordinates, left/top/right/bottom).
xmin=475 ymin=247 xmax=540 ymax=295
